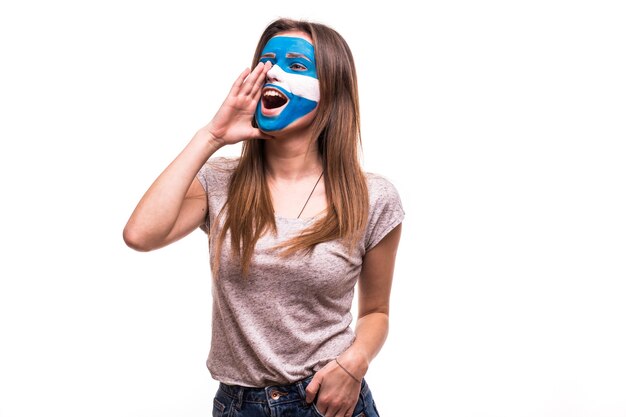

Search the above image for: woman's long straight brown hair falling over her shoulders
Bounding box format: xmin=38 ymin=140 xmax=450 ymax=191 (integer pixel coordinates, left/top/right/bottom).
xmin=213 ymin=19 xmax=369 ymax=276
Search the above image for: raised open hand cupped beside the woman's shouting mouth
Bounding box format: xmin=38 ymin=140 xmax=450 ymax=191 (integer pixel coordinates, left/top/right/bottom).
xmin=201 ymin=62 xmax=272 ymax=145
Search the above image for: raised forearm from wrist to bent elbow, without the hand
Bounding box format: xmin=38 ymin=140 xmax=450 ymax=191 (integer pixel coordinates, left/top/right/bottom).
xmin=124 ymin=129 xmax=220 ymax=248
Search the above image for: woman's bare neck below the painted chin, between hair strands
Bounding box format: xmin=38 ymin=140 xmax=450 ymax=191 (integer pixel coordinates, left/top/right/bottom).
xmin=265 ymin=133 xmax=323 ymax=181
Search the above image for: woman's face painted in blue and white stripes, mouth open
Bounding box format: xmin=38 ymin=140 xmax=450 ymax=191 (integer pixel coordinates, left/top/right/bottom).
xmin=256 ymin=36 xmax=320 ymax=132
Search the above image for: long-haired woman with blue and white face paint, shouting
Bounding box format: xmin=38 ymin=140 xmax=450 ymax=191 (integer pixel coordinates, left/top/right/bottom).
xmin=124 ymin=19 xmax=404 ymax=417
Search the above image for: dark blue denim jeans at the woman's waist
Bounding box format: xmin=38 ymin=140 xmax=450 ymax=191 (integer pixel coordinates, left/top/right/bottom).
xmin=213 ymin=376 xmax=380 ymax=417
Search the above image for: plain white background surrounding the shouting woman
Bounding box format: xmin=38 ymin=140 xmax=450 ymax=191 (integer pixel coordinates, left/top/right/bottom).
xmin=0 ymin=0 xmax=626 ymax=417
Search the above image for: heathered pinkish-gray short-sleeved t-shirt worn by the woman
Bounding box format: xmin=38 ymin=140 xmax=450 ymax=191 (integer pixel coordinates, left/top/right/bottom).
xmin=198 ymin=158 xmax=404 ymax=387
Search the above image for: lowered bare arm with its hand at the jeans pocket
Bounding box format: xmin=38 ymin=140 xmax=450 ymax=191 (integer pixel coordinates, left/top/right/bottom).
xmin=306 ymin=224 xmax=402 ymax=416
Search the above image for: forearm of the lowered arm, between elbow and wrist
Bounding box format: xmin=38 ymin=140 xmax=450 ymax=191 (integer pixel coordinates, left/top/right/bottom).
xmin=338 ymin=312 xmax=389 ymax=379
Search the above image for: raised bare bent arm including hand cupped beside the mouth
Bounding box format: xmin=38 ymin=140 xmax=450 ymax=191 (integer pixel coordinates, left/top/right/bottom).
xmin=124 ymin=63 xmax=271 ymax=251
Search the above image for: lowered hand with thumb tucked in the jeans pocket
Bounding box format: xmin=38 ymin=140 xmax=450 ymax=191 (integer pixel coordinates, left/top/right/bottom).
xmin=306 ymin=358 xmax=361 ymax=417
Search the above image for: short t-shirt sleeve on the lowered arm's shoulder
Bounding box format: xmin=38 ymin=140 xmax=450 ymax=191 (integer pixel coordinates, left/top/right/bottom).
xmin=364 ymin=174 xmax=404 ymax=252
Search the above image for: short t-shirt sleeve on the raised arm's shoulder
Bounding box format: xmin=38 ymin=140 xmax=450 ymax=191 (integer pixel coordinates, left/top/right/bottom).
xmin=196 ymin=157 xmax=238 ymax=233
